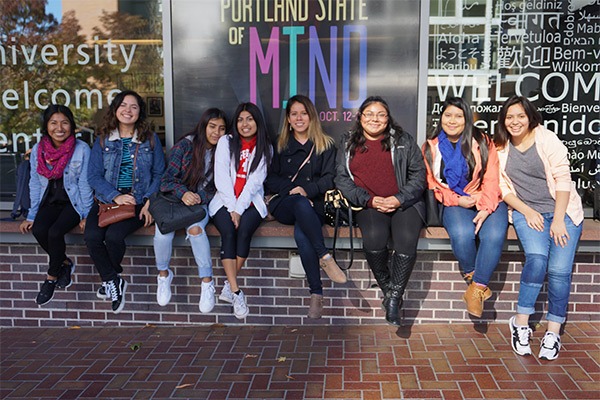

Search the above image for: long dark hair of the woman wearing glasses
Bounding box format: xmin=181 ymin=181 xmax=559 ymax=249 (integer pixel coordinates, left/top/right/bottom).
xmin=346 ymin=96 xmax=404 ymax=157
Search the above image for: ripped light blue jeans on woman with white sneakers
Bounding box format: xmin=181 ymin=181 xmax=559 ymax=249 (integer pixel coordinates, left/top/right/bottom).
xmin=154 ymin=206 xmax=212 ymax=278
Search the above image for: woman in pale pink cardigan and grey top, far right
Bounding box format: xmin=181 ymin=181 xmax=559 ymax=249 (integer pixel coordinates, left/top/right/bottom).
xmin=494 ymin=96 xmax=583 ymax=360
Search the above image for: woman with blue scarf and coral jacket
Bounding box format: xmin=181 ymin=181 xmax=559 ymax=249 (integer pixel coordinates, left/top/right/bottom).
xmin=423 ymin=97 xmax=508 ymax=318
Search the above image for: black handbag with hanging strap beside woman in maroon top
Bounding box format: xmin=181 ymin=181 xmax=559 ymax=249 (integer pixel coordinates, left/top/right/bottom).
xmin=324 ymin=189 xmax=363 ymax=271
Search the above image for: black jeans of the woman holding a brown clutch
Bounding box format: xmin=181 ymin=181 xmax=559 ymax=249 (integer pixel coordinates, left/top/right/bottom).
xmin=83 ymin=203 xmax=144 ymax=282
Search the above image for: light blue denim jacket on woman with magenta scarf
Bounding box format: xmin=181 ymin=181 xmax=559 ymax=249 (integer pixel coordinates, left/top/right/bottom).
xmin=27 ymin=140 xmax=94 ymax=221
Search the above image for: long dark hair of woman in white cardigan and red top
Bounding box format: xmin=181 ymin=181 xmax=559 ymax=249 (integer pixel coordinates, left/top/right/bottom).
xmin=229 ymin=103 xmax=271 ymax=173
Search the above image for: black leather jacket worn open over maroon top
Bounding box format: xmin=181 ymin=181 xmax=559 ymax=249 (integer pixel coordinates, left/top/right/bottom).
xmin=335 ymin=132 xmax=427 ymax=221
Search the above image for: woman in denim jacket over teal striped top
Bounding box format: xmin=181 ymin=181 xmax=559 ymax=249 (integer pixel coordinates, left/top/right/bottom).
xmin=84 ymin=91 xmax=165 ymax=314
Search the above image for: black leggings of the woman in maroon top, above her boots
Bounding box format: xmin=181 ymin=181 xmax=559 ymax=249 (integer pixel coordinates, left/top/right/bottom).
xmin=356 ymin=207 xmax=423 ymax=255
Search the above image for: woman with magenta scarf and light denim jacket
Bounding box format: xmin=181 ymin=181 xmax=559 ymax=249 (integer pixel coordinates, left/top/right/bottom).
xmin=20 ymin=104 xmax=93 ymax=305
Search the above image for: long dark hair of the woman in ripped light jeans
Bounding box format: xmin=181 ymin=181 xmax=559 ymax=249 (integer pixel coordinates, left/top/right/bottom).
xmin=179 ymin=108 xmax=227 ymax=190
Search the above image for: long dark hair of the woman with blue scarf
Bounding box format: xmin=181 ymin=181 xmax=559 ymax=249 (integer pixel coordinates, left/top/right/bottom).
xmin=425 ymin=97 xmax=491 ymax=185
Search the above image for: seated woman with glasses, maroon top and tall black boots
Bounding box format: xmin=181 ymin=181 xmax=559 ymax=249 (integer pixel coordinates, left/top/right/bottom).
xmin=335 ymin=96 xmax=426 ymax=325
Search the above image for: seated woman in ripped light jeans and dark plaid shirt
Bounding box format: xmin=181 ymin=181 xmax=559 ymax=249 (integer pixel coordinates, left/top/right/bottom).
xmin=154 ymin=108 xmax=227 ymax=313
